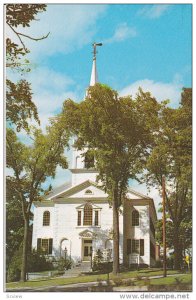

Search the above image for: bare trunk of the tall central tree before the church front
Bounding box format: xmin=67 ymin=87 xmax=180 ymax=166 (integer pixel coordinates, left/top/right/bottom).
xmin=113 ymin=196 xmax=119 ymax=275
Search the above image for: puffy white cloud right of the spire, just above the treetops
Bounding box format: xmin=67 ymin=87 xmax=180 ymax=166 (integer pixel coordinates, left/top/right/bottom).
xmin=119 ymin=75 xmax=183 ymax=106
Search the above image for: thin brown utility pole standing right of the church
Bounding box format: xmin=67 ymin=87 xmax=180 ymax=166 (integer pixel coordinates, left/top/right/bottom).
xmin=162 ymin=175 xmax=167 ymax=277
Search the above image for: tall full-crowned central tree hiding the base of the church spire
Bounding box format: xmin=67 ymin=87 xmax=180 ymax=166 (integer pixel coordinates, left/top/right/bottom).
xmin=56 ymin=84 xmax=160 ymax=274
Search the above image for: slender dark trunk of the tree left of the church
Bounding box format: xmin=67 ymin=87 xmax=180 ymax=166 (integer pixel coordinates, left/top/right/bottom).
xmin=21 ymin=216 xmax=29 ymax=282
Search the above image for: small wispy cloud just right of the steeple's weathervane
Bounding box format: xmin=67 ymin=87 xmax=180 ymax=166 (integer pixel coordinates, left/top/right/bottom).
xmin=103 ymin=23 xmax=137 ymax=44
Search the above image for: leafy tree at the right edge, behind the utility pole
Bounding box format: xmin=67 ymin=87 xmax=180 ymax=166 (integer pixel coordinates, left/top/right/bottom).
xmin=147 ymin=89 xmax=192 ymax=269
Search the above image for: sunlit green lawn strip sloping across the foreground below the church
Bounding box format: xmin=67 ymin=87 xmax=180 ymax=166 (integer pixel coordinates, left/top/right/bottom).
xmin=6 ymin=269 xmax=191 ymax=289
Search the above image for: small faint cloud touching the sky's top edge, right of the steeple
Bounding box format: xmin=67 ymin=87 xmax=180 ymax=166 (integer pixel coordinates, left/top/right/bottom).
xmin=138 ymin=4 xmax=169 ymax=19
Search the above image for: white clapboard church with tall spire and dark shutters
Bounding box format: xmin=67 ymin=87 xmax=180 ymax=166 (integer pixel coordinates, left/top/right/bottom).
xmin=32 ymin=44 xmax=157 ymax=266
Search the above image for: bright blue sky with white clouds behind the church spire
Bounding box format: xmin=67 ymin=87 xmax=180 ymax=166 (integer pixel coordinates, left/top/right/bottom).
xmin=7 ymin=4 xmax=192 ymax=212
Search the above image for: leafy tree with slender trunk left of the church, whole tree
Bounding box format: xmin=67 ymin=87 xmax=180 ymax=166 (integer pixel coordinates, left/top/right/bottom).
xmin=6 ymin=121 xmax=69 ymax=281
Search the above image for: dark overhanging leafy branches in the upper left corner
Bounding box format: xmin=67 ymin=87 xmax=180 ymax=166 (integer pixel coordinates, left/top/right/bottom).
xmin=6 ymin=4 xmax=48 ymax=131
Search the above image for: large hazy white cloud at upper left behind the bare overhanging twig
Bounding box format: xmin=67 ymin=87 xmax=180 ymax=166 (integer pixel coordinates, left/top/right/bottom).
xmin=7 ymin=4 xmax=107 ymax=59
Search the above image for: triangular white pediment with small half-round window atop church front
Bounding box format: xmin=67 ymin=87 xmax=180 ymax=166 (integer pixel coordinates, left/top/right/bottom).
xmin=51 ymin=180 xmax=108 ymax=200
